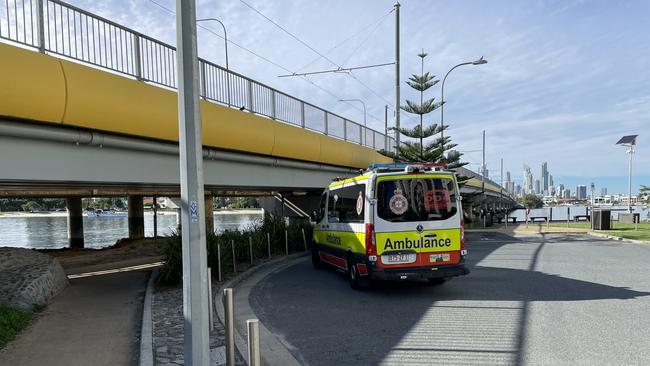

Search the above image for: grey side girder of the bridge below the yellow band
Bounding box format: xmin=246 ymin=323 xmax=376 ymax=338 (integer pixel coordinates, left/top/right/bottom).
xmin=0 ymin=120 xmax=355 ymax=197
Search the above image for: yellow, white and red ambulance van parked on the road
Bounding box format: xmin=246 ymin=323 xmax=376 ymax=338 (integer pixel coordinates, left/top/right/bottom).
xmin=311 ymin=164 xmax=469 ymax=289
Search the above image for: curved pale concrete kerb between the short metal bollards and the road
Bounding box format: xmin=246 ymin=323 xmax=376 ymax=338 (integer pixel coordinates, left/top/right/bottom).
xmin=214 ymin=252 xmax=306 ymax=366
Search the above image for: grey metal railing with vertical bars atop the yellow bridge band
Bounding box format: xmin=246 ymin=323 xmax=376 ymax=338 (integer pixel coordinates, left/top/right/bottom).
xmin=0 ymin=0 xmax=395 ymax=152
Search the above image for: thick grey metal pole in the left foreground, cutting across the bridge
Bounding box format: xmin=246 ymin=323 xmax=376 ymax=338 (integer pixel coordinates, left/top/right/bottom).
xmin=176 ymin=0 xmax=210 ymax=366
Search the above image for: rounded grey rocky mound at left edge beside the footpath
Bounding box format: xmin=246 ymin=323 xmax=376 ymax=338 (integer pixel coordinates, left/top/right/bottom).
xmin=0 ymin=247 xmax=68 ymax=312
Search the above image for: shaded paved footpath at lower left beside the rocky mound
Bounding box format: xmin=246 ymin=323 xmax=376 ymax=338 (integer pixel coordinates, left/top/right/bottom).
xmin=0 ymin=271 xmax=148 ymax=366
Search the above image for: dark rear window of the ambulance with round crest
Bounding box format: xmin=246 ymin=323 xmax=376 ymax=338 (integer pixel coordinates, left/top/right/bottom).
xmin=377 ymin=177 xmax=458 ymax=222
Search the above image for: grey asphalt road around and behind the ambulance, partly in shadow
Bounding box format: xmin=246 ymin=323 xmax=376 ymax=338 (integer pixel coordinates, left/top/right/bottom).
xmin=249 ymin=234 xmax=650 ymax=365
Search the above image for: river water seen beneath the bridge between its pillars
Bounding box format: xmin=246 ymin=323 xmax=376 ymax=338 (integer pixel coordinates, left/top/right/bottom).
xmin=0 ymin=211 xmax=263 ymax=249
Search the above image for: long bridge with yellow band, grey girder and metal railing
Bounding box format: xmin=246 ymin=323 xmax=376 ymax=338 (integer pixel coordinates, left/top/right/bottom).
xmin=0 ymin=0 xmax=514 ymax=249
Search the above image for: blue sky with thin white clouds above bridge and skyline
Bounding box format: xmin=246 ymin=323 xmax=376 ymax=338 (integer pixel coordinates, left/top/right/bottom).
xmin=69 ymin=0 xmax=650 ymax=193
